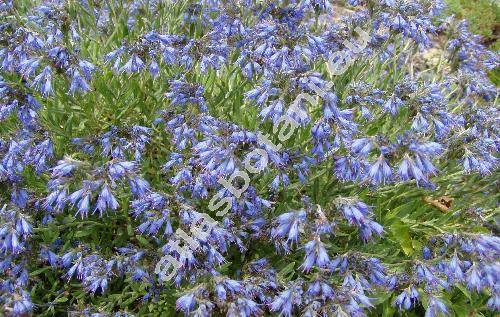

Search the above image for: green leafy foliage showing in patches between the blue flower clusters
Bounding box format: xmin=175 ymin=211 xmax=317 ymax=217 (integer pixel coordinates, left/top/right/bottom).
xmin=0 ymin=0 xmax=500 ymax=317
